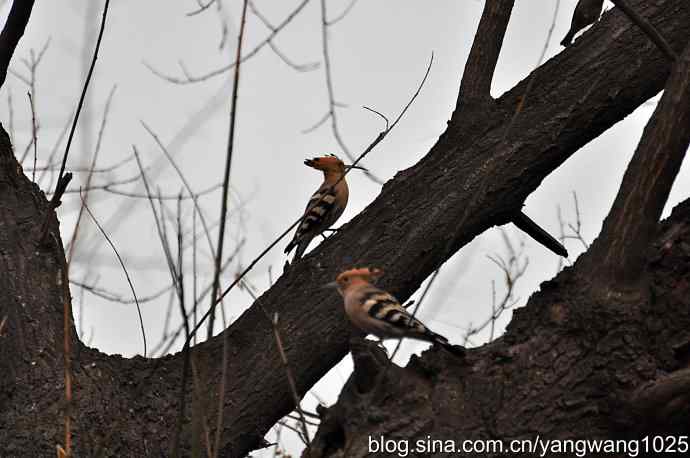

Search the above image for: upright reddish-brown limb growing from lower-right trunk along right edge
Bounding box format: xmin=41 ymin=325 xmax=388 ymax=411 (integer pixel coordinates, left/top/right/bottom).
xmin=588 ymin=41 xmax=690 ymax=288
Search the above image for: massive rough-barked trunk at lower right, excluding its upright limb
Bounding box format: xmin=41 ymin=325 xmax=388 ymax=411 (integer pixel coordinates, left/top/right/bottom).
xmin=305 ymin=200 xmax=690 ymax=458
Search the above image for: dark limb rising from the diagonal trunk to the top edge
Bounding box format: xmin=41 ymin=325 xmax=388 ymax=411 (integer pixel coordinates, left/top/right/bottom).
xmin=458 ymin=0 xmax=515 ymax=108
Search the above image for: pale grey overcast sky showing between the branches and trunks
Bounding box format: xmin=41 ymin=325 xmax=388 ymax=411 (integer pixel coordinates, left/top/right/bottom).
xmin=0 ymin=0 xmax=690 ymax=452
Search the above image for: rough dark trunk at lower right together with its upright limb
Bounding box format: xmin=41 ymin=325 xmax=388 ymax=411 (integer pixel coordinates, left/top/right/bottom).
xmin=305 ymin=41 xmax=690 ymax=457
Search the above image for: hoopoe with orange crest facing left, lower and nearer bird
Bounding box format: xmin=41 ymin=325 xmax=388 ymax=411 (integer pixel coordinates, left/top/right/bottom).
xmin=325 ymin=267 xmax=465 ymax=356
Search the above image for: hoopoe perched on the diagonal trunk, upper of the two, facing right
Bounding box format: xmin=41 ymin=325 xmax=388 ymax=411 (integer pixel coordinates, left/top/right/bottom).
xmin=285 ymin=154 xmax=366 ymax=262
